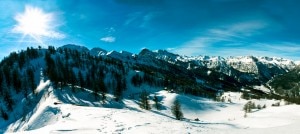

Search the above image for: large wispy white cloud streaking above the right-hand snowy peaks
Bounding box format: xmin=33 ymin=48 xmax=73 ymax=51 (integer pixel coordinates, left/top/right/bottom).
xmin=169 ymin=21 xmax=267 ymax=55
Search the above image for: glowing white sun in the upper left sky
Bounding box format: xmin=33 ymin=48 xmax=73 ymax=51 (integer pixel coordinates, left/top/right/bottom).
xmin=13 ymin=6 xmax=63 ymax=45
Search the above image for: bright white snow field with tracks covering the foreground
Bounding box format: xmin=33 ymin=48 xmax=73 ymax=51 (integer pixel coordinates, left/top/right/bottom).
xmin=7 ymin=83 xmax=300 ymax=134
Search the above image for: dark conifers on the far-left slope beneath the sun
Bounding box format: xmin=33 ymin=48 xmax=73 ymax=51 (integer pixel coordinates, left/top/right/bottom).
xmin=0 ymin=47 xmax=42 ymax=120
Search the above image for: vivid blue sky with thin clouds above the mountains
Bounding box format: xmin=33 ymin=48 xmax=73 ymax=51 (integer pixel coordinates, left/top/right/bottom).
xmin=0 ymin=0 xmax=300 ymax=60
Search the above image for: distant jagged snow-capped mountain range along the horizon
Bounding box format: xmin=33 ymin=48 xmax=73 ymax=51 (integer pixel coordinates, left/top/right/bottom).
xmin=59 ymin=46 xmax=297 ymax=85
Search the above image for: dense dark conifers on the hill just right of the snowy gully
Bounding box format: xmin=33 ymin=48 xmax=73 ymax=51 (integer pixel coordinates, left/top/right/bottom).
xmin=45 ymin=46 xmax=127 ymax=101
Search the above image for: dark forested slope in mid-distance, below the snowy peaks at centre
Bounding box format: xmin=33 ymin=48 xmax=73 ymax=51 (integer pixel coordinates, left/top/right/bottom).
xmin=131 ymin=61 xmax=216 ymax=98
